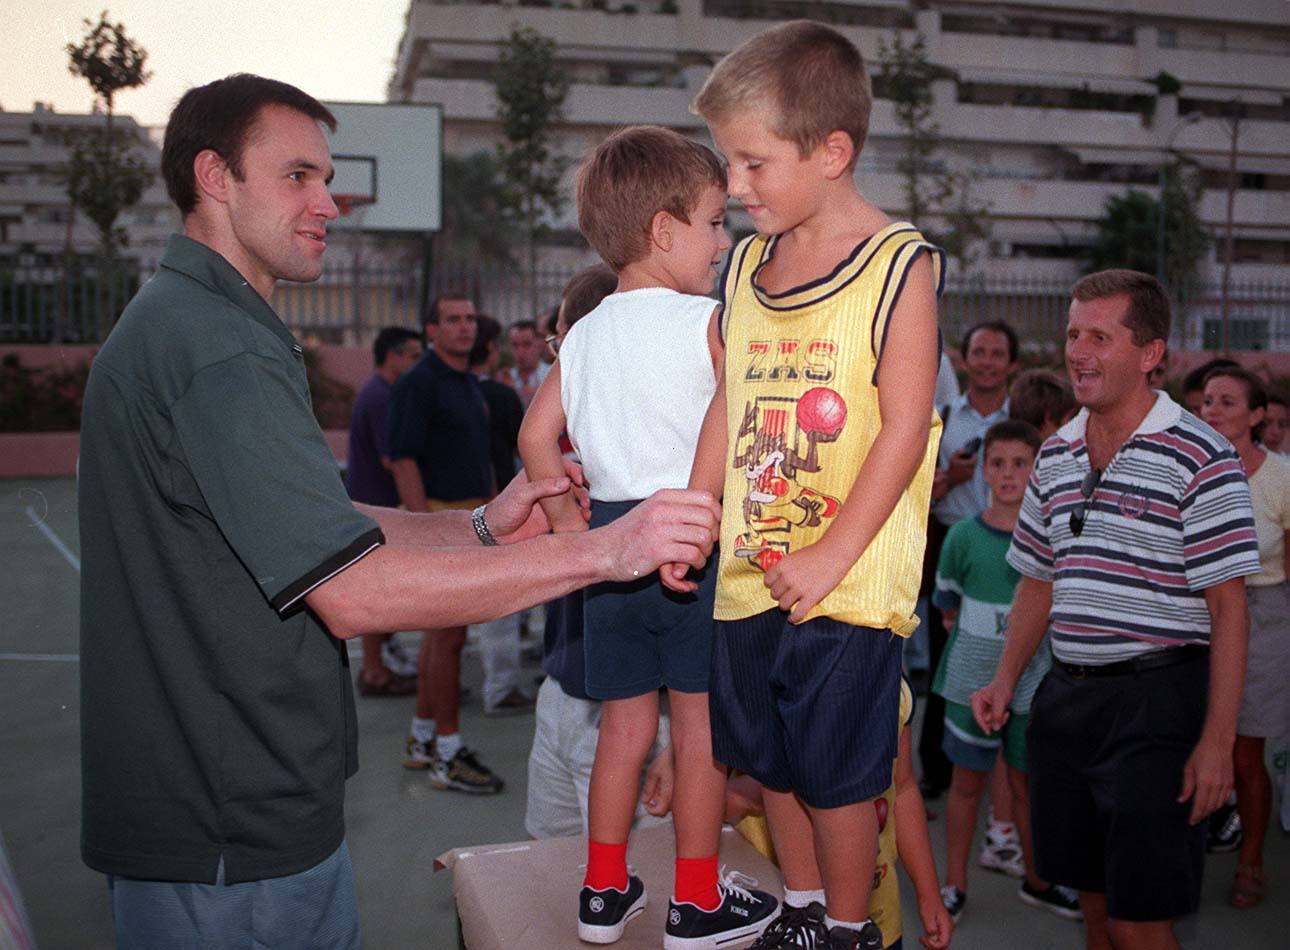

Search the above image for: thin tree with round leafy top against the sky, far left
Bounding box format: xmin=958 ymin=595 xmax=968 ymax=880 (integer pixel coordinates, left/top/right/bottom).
xmin=65 ymin=10 xmax=152 ymax=259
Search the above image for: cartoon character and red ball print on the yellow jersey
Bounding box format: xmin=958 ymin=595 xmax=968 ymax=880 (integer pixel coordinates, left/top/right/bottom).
xmin=733 ymin=386 xmax=846 ymax=572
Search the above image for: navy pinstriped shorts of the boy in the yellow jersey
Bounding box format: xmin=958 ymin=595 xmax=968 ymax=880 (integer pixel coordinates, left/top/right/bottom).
xmin=711 ymin=608 xmax=903 ymax=808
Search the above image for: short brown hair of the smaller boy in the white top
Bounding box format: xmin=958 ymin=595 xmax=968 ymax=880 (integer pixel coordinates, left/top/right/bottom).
xmin=577 ymin=125 xmax=726 ymax=271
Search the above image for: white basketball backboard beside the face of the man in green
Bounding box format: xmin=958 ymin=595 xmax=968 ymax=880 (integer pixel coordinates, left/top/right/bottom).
xmin=324 ymin=102 xmax=444 ymax=234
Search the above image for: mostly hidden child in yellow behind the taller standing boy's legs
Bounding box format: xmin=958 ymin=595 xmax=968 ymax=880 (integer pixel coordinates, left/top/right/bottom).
xmin=728 ymin=678 xmax=955 ymax=950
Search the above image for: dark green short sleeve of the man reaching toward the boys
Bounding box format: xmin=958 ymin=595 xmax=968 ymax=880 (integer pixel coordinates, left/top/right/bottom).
xmin=170 ymin=352 xmax=384 ymax=613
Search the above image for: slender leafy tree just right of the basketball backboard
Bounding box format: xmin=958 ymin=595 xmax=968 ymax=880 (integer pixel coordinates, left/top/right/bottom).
xmin=494 ymin=27 xmax=569 ymax=311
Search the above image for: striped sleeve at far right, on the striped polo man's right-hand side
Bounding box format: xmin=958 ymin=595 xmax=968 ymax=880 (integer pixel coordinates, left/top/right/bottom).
xmin=1178 ymin=449 xmax=1259 ymax=590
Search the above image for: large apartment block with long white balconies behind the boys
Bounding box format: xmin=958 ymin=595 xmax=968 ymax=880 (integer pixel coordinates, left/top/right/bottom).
xmin=388 ymin=0 xmax=1290 ymax=281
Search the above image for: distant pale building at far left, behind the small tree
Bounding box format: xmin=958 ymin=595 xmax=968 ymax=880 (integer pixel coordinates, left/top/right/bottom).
xmin=0 ymin=102 xmax=179 ymax=268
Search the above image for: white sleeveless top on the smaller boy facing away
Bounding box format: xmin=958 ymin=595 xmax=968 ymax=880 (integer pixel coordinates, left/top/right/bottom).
xmin=560 ymin=287 xmax=716 ymax=501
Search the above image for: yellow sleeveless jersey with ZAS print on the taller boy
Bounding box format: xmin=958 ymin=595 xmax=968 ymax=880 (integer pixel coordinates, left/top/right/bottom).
xmin=716 ymin=222 xmax=943 ymax=636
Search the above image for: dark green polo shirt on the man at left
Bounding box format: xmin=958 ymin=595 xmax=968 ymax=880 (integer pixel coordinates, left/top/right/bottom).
xmin=79 ymin=235 xmax=383 ymax=884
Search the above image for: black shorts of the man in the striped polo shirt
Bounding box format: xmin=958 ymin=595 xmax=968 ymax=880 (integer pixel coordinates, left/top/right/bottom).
xmin=1026 ymin=657 xmax=1209 ymax=920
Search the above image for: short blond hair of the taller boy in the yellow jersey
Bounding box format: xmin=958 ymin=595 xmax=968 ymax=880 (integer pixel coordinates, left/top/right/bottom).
xmin=690 ymin=19 xmax=873 ymax=168
